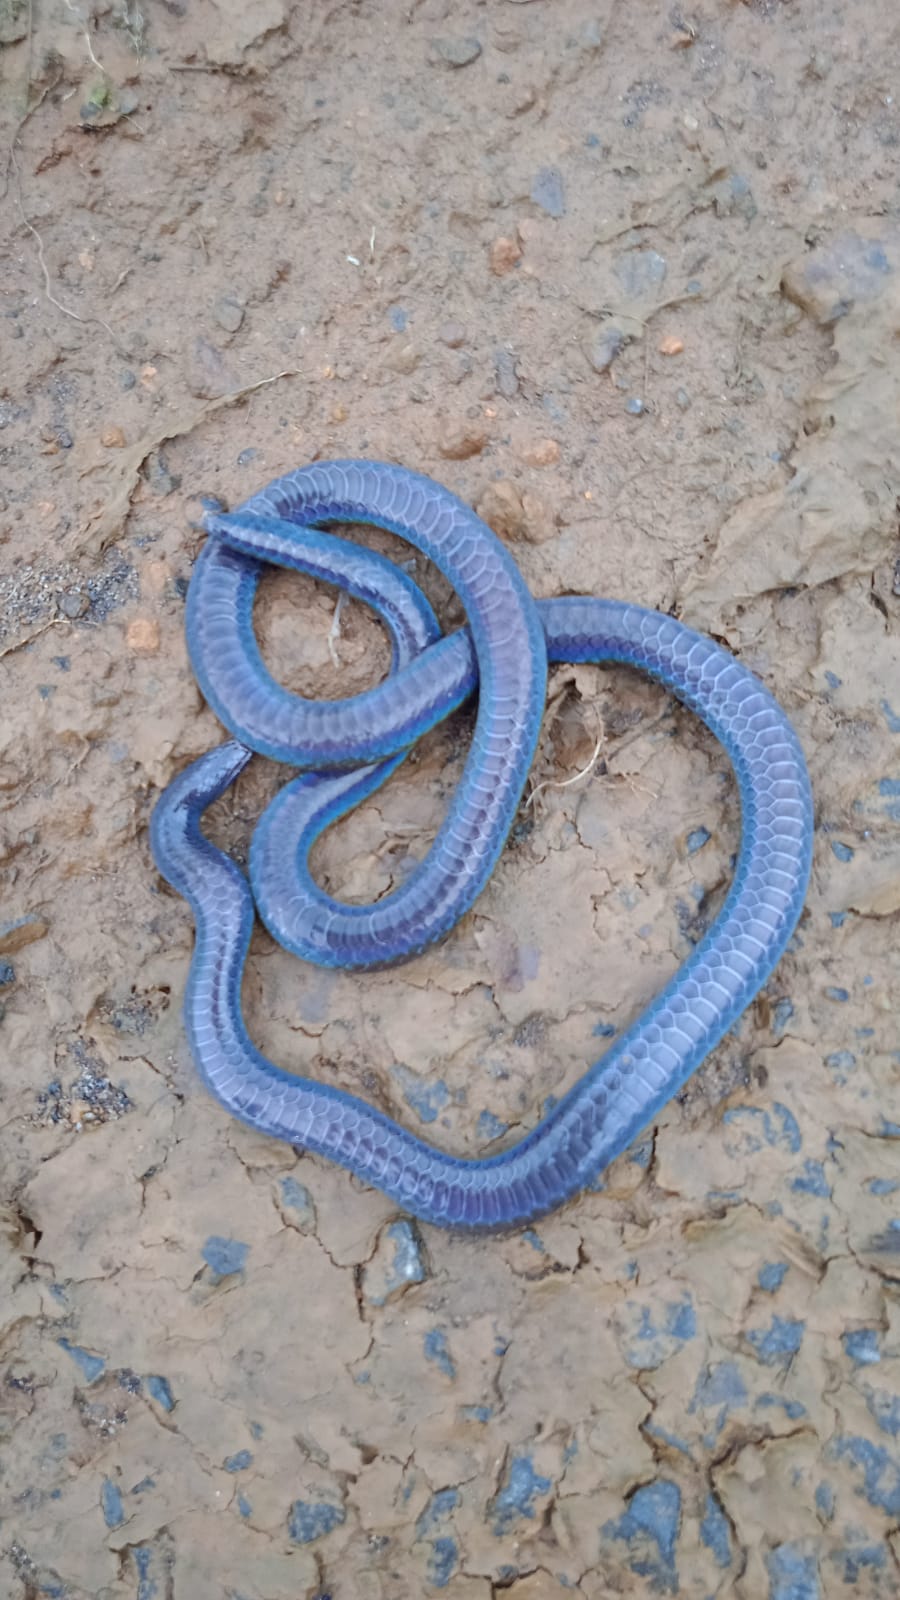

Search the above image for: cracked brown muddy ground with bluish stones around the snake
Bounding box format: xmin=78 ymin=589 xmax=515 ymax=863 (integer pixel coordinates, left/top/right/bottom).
xmin=0 ymin=0 xmax=900 ymax=1600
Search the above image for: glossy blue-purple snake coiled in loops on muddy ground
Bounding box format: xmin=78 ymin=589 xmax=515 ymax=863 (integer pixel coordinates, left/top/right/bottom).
xmin=151 ymin=461 xmax=814 ymax=1230
